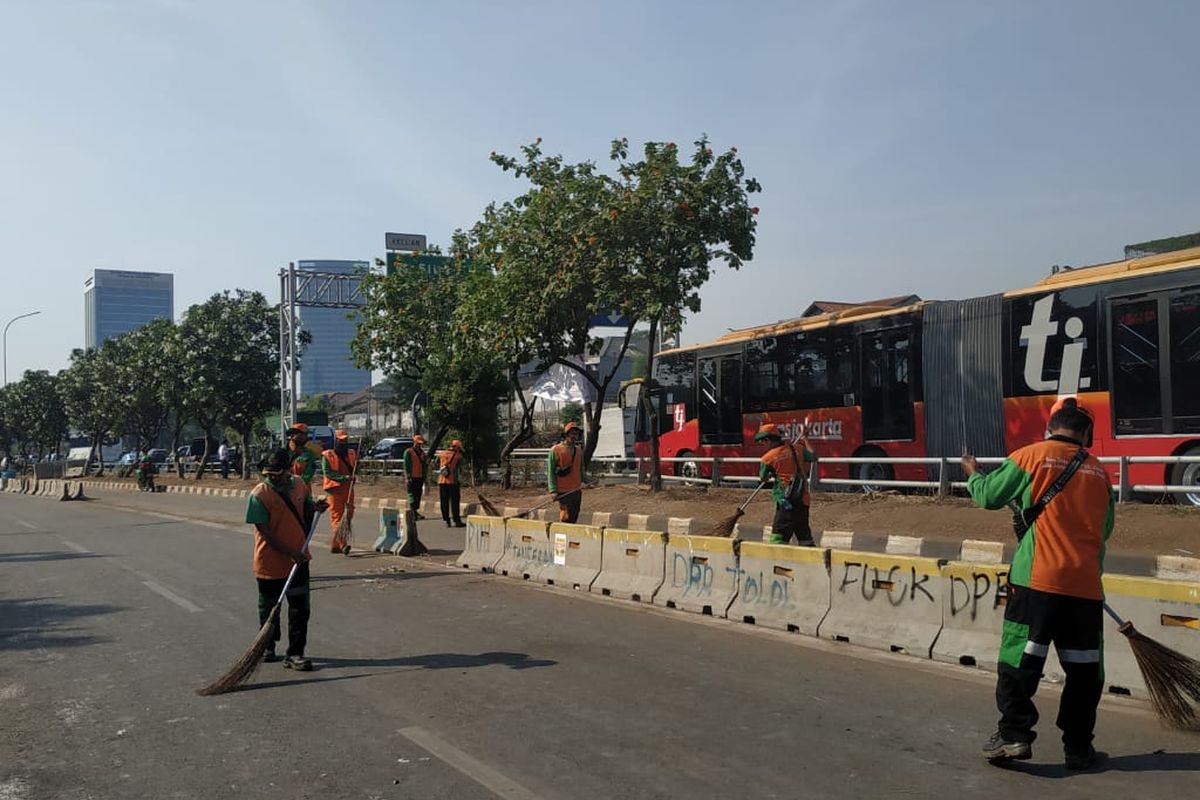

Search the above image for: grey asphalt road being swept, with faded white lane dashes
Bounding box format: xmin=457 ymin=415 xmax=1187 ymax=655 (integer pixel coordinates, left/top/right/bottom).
xmin=0 ymin=494 xmax=1200 ymax=800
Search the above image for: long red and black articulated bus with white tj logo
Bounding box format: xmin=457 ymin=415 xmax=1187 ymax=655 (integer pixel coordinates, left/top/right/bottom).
xmin=636 ymin=248 xmax=1200 ymax=505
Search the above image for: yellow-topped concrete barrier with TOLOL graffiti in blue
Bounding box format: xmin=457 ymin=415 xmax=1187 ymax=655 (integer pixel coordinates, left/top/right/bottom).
xmin=726 ymin=541 xmax=829 ymax=636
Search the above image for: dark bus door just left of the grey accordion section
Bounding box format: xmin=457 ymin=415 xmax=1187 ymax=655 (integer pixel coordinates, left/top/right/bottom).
xmin=860 ymin=327 xmax=916 ymax=441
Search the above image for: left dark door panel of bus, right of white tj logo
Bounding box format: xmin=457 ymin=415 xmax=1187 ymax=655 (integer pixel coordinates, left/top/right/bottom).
xmin=1112 ymin=297 xmax=1163 ymax=434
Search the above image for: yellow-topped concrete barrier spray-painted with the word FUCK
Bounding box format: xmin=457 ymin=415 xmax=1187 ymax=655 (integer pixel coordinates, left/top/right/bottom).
xmin=818 ymin=551 xmax=942 ymax=658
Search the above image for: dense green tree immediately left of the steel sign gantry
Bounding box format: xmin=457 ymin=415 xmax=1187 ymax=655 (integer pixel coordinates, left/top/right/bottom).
xmin=180 ymin=289 xmax=280 ymax=480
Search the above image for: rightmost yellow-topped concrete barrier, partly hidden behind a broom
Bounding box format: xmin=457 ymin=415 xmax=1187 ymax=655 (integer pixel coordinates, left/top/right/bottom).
xmin=1104 ymin=575 xmax=1200 ymax=697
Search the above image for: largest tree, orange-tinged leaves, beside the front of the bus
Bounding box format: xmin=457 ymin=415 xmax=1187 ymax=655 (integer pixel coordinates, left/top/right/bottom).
xmin=463 ymin=137 xmax=761 ymax=488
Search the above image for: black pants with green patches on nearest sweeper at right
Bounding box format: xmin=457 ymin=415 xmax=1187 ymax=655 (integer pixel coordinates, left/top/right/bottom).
xmin=996 ymin=585 xmax=1104 ymax=747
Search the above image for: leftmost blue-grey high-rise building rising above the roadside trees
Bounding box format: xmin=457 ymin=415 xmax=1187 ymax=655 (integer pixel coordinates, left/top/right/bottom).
xmin=83 ymin=270 xmax=175 ymax=348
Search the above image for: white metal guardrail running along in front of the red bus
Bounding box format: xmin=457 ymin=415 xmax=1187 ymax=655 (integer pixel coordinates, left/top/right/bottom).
xmin=512 ymin=449 xmax=1200 ymax=503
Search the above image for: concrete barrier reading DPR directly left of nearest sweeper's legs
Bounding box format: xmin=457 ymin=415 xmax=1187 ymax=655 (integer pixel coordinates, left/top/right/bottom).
xmin=932 ymin=561 xmax=1008 ymax=669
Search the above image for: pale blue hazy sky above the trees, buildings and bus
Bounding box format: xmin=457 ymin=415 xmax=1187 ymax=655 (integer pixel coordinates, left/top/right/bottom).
xmin=0 ymin=0 xmax=1200 ymax=378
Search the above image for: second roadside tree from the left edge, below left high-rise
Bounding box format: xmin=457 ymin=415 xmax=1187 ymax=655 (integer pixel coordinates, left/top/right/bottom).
xmin=58 ymin=350 xmax=121 ymax=475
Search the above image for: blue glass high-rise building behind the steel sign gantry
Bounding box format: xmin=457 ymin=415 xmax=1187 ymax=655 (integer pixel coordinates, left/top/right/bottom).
xmin=296 ymin=261 xmax=371 ymax=397
